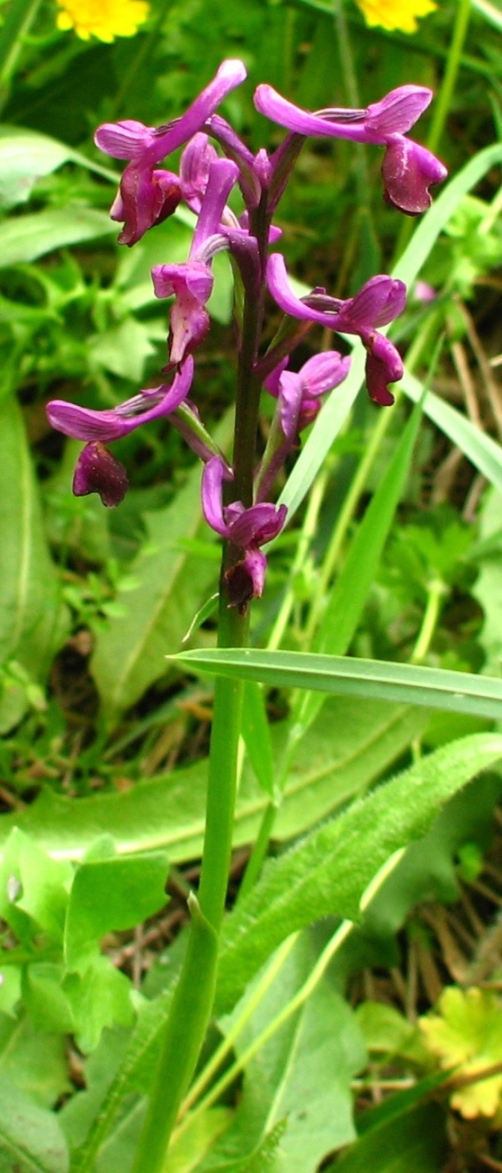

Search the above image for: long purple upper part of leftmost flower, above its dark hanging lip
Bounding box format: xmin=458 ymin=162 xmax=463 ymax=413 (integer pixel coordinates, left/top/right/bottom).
xmin=47 ymin=355 xmax=194 ymax=441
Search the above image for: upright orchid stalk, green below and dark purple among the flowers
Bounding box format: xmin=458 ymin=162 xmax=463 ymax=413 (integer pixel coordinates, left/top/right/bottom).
xmin=133 ymin=194 xmax=269 ymax=1173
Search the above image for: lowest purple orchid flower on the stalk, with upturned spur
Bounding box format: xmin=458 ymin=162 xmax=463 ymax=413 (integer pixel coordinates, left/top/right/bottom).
xmin=202 ymin=456 xmax=287 ymax=613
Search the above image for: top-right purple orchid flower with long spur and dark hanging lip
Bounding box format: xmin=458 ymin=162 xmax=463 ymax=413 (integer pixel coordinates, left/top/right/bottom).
xmin=255 ymin=86 xmax=447 ymax=216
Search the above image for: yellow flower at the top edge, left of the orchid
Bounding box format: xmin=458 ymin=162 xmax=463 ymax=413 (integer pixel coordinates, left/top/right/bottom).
xmin=56 ymin=0 xmax=149 ymax=41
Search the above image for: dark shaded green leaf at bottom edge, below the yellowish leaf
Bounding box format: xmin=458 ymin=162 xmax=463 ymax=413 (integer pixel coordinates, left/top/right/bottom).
xmin=326 ymin=1104 xmax=447 ymax=1173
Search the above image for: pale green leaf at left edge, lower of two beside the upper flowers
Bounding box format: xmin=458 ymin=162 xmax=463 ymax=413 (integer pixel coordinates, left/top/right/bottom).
xmin=0 ymin=204 xmax=117 ymax=269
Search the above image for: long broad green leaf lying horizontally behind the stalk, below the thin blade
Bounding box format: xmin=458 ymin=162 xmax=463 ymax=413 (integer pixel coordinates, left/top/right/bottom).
xmin=0 ymin=698 xmax=428 ymax=862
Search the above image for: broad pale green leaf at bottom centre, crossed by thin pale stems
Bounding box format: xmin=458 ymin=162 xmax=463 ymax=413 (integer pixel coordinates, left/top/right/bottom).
xmin=201 ymin=934 xmax=366 ymax=1173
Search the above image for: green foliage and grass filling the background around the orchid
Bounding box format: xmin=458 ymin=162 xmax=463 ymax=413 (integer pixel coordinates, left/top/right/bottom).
xmin=0 ymin=0 xmax=502 ymax=1173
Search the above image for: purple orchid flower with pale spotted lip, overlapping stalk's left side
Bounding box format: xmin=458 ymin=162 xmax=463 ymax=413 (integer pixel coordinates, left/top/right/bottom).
xmin=151 ymin=158 xmax=238 ymax=362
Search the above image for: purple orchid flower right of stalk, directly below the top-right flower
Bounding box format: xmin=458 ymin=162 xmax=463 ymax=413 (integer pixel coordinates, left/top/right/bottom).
xmin=266 ymin=252 xmax=406 ymax=407
